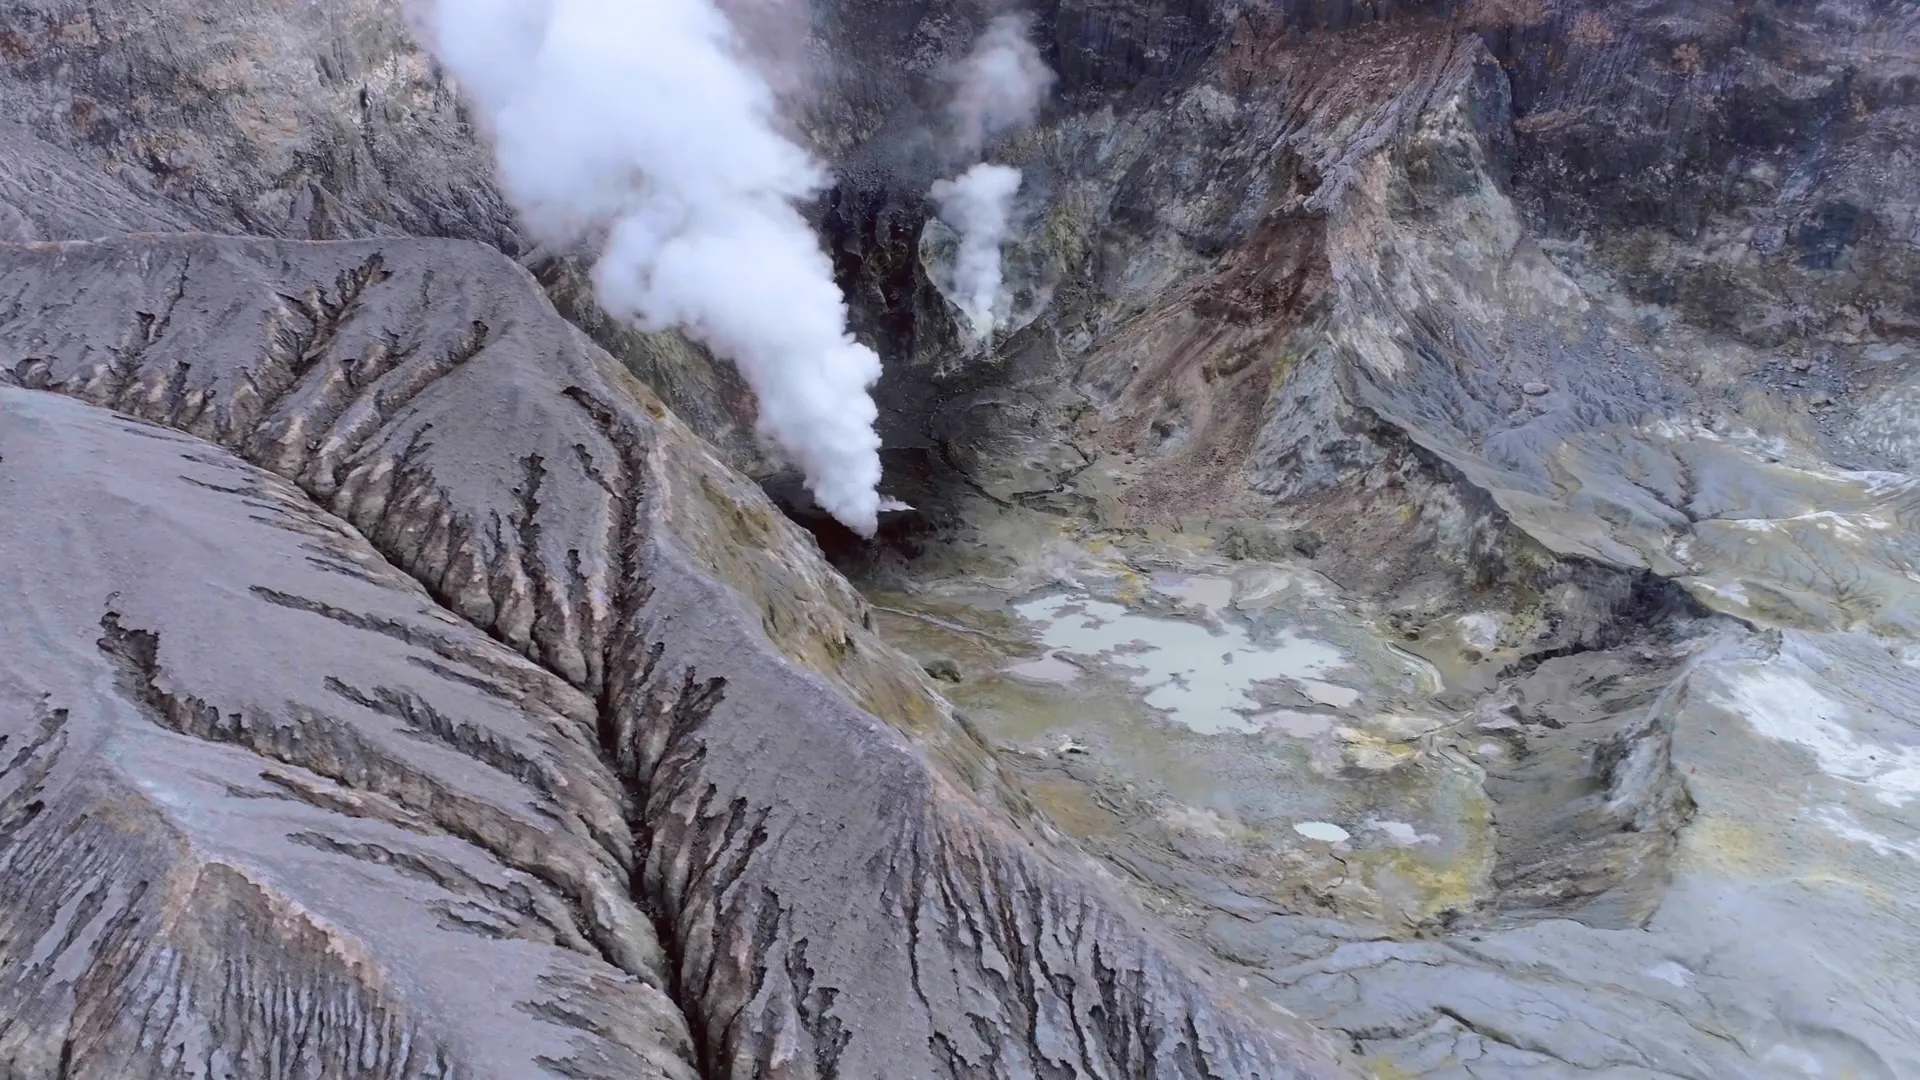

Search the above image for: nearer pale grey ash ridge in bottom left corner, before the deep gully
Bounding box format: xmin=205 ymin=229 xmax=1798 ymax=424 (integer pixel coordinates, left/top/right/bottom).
xmin=0 ymin=388 xmax=697 ymax=1078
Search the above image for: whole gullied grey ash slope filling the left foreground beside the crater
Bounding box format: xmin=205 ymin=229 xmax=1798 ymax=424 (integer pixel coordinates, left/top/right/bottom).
xmin=0 ymin=236 xmax=1344 ymax=1078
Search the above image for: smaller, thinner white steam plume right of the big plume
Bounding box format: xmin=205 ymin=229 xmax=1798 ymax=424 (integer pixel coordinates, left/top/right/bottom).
xmin=933 ymin=15 xmax=1054 ymax=342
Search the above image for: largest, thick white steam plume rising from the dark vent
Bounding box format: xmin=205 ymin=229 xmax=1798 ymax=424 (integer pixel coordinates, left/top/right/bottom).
xmin=434 ymin=0 xmax=879 ymax=536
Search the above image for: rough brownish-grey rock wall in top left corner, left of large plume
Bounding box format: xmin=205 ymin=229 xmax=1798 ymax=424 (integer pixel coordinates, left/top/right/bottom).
xmin=0 ymin=0 xmax=520 ymax=250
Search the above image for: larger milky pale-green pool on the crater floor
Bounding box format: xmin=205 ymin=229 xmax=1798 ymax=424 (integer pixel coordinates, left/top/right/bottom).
xmin=1010 ymin=575 xmax=1359 ymax=734
